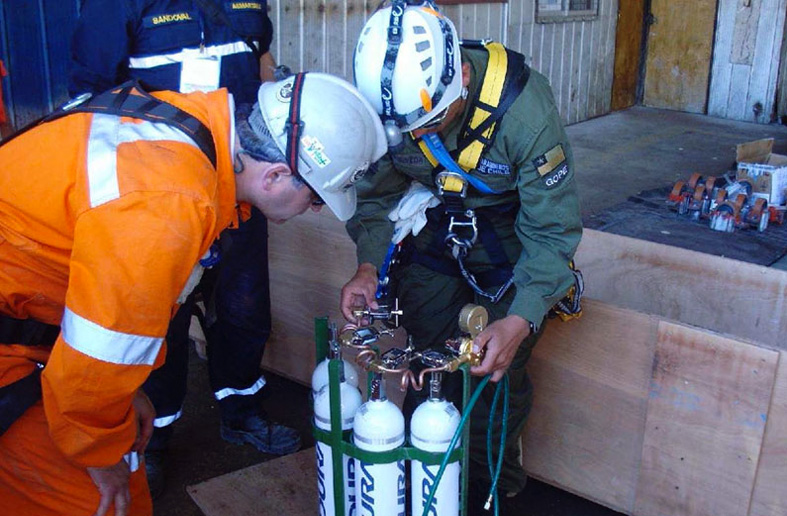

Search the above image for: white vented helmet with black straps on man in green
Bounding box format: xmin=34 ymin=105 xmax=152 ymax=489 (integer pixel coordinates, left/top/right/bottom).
xmin=353 ymin=0 xmax=462 ymax=136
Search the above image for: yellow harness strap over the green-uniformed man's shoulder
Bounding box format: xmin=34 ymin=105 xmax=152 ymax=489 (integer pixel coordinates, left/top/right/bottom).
xmin=456 ymin=41 xmax=508 ymax=170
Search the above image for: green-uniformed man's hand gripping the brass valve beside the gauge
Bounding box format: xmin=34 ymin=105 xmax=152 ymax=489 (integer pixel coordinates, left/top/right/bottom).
xmin=470 ymin=315 xmax=530 ymax=382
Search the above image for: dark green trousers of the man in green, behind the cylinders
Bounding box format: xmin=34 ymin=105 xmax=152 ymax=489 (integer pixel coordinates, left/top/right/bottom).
xmin=394 ymin=264 xmax=541 ymax=492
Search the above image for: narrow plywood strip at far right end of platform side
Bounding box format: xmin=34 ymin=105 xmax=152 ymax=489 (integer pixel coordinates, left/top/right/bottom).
xmin=749 ymin=351 xmax=787 ymax=516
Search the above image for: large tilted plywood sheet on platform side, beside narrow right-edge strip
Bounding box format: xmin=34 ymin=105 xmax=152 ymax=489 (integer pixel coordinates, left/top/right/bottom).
xmin=635 ymin=322 xmax=778 ymax=516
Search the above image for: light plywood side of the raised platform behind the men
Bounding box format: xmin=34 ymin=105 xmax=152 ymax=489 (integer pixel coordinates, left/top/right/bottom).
xmin=263 ymin=218 xmax=787 ymax=516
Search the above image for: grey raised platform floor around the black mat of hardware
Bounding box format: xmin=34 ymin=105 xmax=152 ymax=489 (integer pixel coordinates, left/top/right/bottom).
xmin=566 ymin=106 xmax=787 ymax=217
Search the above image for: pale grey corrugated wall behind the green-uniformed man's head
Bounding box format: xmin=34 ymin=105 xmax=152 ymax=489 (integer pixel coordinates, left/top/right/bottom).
xmin=270 ymin=0 xmax=618 ymax=123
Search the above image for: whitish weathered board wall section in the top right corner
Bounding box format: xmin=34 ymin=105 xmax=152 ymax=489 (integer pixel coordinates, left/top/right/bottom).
xmin=708 ymin=0 xmax=787 ymax=123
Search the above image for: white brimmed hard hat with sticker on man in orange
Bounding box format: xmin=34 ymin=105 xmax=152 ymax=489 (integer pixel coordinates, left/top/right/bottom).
xmin=254 ymin=73 xmax=387 ymax=221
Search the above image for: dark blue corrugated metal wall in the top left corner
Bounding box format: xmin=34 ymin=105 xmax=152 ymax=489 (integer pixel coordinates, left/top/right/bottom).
xmin=0 ymin=0 xmax=80 ymax=127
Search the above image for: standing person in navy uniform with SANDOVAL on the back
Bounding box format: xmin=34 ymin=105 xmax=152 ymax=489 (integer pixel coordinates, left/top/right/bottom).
xmin=69 ymin=0 xmax=300 ymax=498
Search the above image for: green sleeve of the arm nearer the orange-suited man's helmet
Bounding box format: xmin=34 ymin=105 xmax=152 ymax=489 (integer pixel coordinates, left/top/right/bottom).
xmin=346 ymin=154 xmax=410 ymax=271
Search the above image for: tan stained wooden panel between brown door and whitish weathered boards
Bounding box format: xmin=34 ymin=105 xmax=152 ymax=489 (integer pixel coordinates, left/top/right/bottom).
xmin=644 ymin=0 xmax=716 ymax=113
